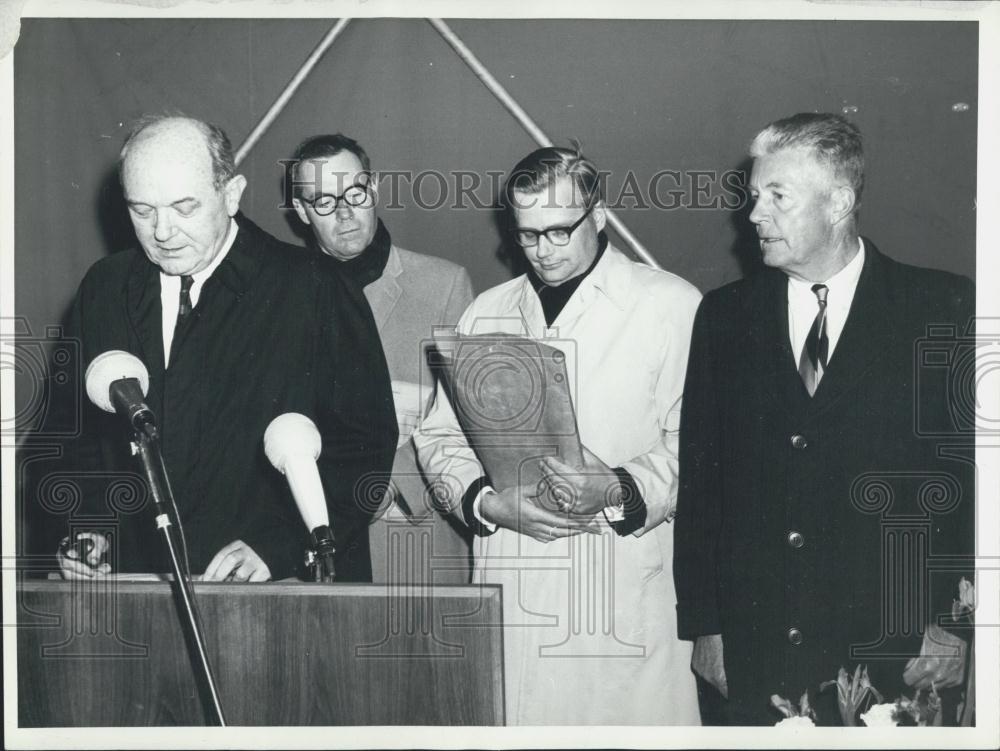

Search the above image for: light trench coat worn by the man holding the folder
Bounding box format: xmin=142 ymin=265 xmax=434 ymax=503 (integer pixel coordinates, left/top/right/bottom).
xmin=414 ymin=247 xmax=701 ymax=725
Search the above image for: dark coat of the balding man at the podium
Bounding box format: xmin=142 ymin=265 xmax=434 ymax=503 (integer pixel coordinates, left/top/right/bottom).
xmin=60 ymin=216 xmax=396 ymax=581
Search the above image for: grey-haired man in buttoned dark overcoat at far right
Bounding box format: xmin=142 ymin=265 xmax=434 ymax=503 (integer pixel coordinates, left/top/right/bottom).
xmin=674 ymin=114 xmax=975 ymax=724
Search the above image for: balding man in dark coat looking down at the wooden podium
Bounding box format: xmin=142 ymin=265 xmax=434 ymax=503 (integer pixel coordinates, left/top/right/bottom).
xmin=59 ymin=117 xmax=396 ymax=581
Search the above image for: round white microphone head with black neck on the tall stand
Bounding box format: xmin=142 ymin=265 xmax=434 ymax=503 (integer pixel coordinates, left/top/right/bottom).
xmin=84 ymin=349 xmax=156 ymax=438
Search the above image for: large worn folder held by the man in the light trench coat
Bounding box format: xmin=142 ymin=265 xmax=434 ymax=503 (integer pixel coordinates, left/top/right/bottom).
xmin=436 ymin=334 xmax=583 ymax=490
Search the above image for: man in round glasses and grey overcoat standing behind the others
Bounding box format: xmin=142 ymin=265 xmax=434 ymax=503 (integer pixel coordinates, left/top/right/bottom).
xmin=291 ymin=133 xmax=472 ymax=584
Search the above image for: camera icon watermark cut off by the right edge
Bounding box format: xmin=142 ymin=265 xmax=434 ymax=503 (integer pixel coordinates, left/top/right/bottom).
xmin=913 ymin=319 xmax=1000 ymax=437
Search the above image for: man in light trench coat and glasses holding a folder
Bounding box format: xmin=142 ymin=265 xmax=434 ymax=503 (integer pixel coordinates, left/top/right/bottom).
xmin=414 ymin=148 xmax=701 ymax=725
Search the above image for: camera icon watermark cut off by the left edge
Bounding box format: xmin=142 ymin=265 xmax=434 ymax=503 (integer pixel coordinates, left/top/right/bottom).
xmin=0 ymin=316 xmax=82 ymax=443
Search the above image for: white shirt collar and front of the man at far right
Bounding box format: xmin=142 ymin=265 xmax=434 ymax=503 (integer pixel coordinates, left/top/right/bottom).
xmin=788 ymin=237 xmax=865 ymax=363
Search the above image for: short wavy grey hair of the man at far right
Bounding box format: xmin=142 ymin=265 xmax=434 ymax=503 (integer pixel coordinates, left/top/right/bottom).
xmin=749 ymin=112 xmax=865 ymax=211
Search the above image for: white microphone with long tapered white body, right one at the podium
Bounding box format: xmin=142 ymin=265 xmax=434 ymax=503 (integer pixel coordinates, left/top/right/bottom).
xmin=264 ymin=412 xmax=335 ymax=582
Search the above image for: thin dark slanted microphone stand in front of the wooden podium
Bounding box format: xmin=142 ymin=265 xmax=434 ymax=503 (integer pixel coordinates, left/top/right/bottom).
xmin=135 ymin=423 xmax=226 ymax=727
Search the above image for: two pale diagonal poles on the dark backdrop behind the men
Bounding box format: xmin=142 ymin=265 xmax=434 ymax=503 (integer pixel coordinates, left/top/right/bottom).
xmin=235 ymin=18 xmax=662 ymax=269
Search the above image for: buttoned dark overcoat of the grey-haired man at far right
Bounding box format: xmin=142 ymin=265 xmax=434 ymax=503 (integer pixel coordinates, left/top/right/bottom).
xmin=674 ymin=240 xmax=975 ymax=723
